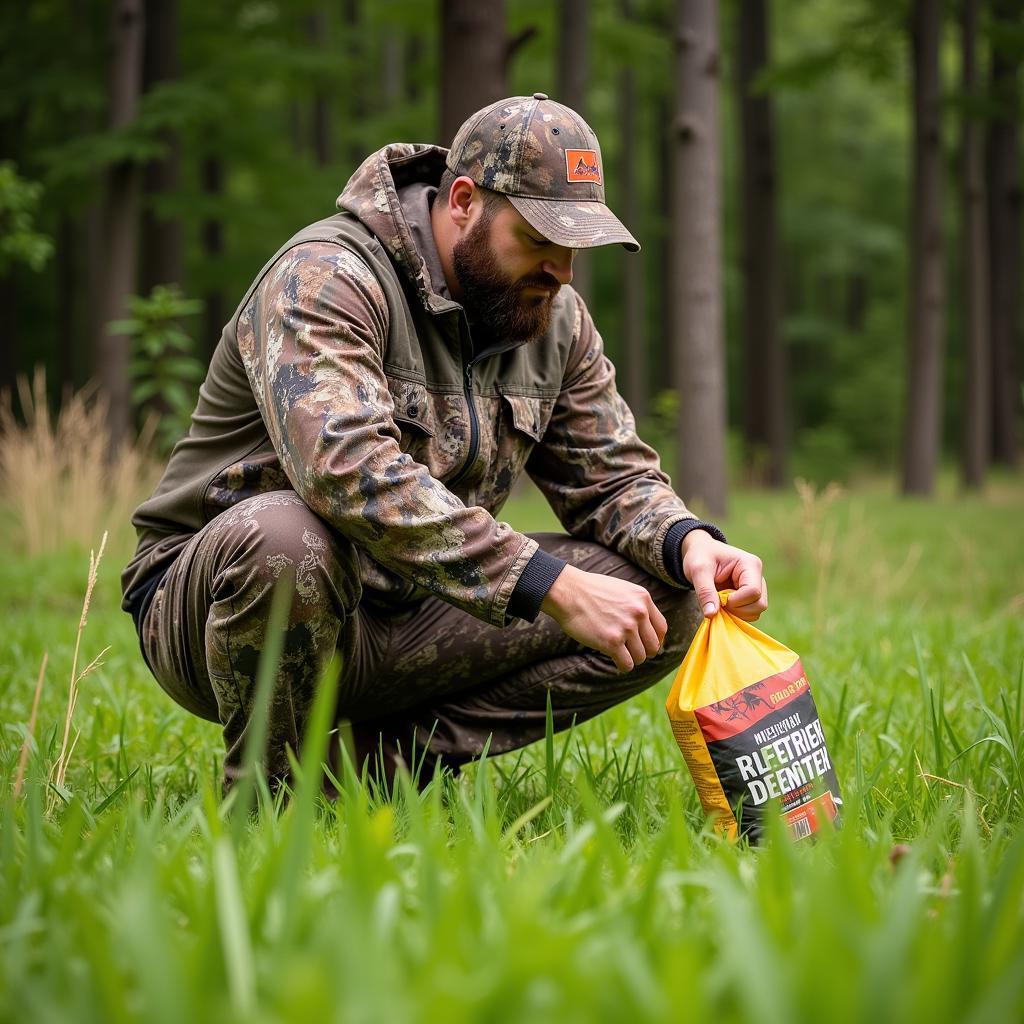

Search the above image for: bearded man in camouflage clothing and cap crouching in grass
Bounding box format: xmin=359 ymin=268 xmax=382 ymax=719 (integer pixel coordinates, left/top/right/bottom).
xmin=123 ymin=93 xmax=767 ymax=786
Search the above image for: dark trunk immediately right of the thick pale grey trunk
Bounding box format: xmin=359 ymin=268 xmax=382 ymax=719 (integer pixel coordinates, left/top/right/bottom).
xmin=738 ymin=0 xmax=787 ymax=487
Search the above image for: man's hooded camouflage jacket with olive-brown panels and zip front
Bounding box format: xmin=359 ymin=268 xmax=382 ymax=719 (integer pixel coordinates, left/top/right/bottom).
xmin=122 ymin=144 xmax=712 ymax=626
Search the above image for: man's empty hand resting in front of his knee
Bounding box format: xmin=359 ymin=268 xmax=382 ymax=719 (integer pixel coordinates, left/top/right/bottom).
xmin=541 ymin=565 xmax=669 ymax=672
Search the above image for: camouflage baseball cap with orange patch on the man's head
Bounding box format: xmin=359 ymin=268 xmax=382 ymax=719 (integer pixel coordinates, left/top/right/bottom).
xmin=447 ymin=92 xmax=640 ymax=252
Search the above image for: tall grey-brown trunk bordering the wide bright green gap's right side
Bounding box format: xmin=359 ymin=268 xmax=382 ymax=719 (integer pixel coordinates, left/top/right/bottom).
xmin=903 ymin=0 xmax=945 ymax=495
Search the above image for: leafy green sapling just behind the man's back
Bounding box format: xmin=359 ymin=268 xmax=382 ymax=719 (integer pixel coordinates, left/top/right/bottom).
xmin=110 ymin=285 xmax=206 ymax=451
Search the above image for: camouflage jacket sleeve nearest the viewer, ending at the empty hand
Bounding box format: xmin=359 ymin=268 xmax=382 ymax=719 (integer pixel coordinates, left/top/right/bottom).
xmin=238 ymin=242 xmax=538 ymax=626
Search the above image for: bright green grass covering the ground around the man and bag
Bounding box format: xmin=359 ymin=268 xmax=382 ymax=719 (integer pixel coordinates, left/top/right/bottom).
xmin=0 ymin=480 xmax=1024 ymax=1024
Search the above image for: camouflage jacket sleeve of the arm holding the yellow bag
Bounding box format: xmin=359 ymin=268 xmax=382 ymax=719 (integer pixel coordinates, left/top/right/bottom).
xmin=526 ymin=296 xmax=696 ymax=586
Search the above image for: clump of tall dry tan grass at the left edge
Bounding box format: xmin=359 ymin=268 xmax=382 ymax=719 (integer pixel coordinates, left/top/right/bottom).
xmin=0 ymin=368 xmax=156 ymax=555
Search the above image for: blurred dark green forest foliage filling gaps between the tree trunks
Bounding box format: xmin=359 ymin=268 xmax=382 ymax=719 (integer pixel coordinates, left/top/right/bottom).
xmin=0 ymin=0 xmax=1024 ymax=477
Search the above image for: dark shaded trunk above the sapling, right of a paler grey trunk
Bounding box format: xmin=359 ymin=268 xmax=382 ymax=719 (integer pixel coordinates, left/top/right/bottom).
xmin=141 ymin=0 xmax=184 ymax=294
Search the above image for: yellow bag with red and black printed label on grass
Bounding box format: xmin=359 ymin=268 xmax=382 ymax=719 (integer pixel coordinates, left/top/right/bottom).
xmin=667 ymin=591 xmax=843 ymax=843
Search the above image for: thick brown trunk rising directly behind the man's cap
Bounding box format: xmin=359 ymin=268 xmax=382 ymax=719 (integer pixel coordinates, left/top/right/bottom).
xmin=441 ymin=0 xmax=507 ymax=145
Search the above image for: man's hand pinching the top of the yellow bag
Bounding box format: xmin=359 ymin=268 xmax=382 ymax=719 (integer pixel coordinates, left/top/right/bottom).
xmin=682 ymin=529 xmax=768 ymax=623
